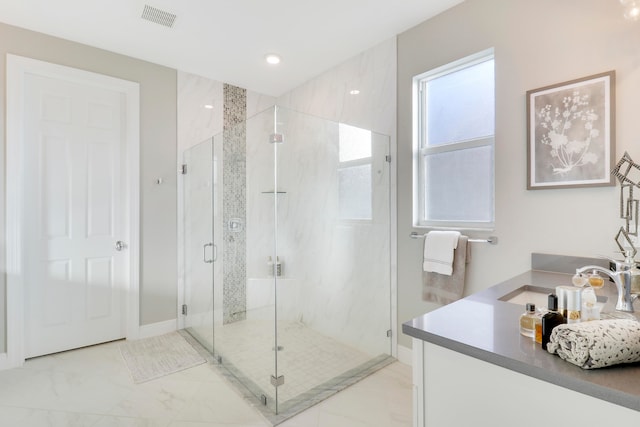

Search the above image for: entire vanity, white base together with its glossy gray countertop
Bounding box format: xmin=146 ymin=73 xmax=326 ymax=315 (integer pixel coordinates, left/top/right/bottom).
xmin=402 ymin=269 xmax=640 ymax=427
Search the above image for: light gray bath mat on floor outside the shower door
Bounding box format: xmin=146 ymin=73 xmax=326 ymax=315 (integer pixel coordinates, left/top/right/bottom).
xmin=120 ymin=332 xmax=205 ymax=384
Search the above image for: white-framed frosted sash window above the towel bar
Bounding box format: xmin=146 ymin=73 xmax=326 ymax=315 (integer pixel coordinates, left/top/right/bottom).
xmin=414 ymin=49 xmax=495 ymax=228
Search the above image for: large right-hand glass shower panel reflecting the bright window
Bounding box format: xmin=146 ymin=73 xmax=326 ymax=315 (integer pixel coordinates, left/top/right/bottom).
xmin=273 ymin=108 xmax=391 ymax=411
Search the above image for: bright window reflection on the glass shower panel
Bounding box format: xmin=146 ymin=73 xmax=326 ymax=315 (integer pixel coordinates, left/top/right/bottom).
xmin=338 ymin=123 xmax=373 ymax=220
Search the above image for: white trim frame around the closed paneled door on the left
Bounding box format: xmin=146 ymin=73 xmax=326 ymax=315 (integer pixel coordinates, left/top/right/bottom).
xmin=0 ymin=54 xmax=140 ymax=369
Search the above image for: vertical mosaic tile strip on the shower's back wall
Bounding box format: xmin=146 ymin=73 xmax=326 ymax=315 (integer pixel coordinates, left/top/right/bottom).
xmin=222 ymin=84 xmax=247 ymax=324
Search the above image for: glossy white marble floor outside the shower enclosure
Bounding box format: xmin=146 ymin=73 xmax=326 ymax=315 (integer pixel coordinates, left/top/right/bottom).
xmin=0 ymin=343 xmax=412 ymax=427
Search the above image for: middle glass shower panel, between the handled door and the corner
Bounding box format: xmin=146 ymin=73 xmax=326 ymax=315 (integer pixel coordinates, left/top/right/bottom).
xmin=216 ymin=109 xmax=277 ymax=413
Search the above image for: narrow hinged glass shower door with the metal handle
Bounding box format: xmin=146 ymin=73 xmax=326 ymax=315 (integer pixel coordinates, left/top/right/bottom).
xmin=183 ymin=139 xmax=216 ymax=354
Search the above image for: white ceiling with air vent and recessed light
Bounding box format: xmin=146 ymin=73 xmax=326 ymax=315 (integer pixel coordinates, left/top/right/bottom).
xmin=0 ymin=0 xmax=463 ymax=96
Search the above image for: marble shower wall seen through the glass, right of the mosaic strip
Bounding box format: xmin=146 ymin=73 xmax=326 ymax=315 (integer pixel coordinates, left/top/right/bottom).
xmin=247 ymin=108 xmax=390 ymax=356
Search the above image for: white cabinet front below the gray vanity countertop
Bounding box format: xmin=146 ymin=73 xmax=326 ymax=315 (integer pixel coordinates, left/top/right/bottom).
xmin=413 ymin=338 xmax=640 ymax=427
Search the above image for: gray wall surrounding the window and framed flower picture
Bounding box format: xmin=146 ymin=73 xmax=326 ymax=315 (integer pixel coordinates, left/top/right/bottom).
xmin=398 ymin=0 xmax=640 ymax=347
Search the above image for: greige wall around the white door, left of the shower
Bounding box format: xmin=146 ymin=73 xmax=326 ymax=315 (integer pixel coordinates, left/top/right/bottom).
xmin=0 ymin=23 xmax=177 ymax=352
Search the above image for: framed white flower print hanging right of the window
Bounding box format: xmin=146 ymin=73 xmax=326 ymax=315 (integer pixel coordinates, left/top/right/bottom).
xmin=526 ymin=70 xmax=615 ymax=190
